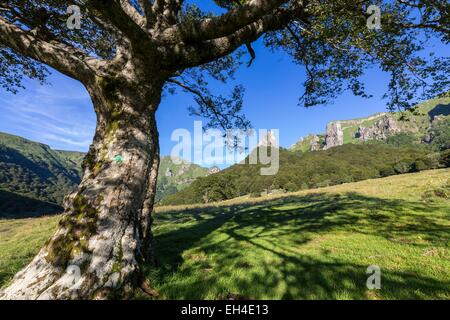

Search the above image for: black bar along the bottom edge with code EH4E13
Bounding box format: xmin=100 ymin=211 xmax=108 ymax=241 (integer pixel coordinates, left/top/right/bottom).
xmin=0 ymin=300 xmax=450 ymax=320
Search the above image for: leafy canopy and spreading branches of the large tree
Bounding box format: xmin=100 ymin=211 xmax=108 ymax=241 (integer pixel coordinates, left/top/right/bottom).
xmin=0 ymin=0 xmax=450 ymax=124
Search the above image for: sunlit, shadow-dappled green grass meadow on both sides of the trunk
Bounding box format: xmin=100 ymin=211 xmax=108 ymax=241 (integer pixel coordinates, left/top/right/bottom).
xmin=0 ymin=169 xmax=450 ymax=299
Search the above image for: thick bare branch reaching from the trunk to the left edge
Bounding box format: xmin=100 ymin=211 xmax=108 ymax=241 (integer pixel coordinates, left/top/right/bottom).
xmin=0 ymin=17 xmax=101 ymax=82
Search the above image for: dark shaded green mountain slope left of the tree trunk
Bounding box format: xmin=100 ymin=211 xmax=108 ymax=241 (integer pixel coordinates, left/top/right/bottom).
xmin=0 ymin=133 xmax=84 ymax=216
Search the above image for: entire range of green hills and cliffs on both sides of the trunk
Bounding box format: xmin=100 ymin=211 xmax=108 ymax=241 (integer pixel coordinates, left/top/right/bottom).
xmin=0 ymin=98 xmax=450 ymax=216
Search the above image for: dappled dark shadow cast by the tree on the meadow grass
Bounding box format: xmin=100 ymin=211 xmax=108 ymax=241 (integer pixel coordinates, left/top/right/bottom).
xmin=150 ymin=193 xmax=450 ymax=299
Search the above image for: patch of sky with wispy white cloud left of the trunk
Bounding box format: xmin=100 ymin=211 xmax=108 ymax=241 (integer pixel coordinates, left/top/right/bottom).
xmin=0 ymin=79 xmax=95 ymax=151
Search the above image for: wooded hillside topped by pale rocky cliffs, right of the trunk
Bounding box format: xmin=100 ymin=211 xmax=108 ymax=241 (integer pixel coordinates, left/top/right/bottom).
xmin=161 ymin=98 xmax=450 ymax=205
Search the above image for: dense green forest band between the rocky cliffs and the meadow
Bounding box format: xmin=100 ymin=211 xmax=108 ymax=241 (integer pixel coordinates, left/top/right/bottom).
xmin=162 ymin=140 xmax=450 ymax=205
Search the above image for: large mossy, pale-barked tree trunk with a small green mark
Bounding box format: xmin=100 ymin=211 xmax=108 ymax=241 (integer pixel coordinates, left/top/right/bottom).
xmin=0 ymin=77 xmax=162 ymax=299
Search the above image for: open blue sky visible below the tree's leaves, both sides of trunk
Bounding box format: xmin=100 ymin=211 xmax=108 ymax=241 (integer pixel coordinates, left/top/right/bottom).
xmin=0 ymin=1 xmax=448 ymax=168
